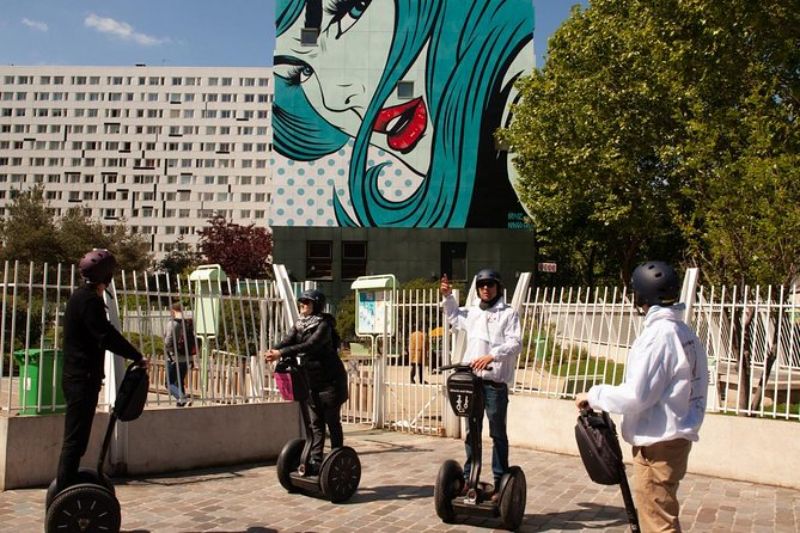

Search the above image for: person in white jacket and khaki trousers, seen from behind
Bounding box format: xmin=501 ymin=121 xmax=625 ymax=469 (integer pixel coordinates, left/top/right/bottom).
xmin=576 ymin=261 xmax=708 ymax=533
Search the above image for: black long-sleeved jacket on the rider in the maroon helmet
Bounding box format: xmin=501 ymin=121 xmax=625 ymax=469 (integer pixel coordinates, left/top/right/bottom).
xmin=64 ymin=285 xmax=142 ymax=381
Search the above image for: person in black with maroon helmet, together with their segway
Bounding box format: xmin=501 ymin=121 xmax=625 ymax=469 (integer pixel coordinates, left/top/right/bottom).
xmin=45 ymin=249 xmax=148 ymax=531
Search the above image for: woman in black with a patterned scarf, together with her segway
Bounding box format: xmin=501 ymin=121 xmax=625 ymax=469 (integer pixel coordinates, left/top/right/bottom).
xmin=267 ymin=290 xmax=361 ymax=503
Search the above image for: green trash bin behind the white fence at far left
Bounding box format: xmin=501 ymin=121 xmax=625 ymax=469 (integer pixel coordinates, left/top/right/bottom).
xmin=14 ymin=348 xmax=66 ymax=415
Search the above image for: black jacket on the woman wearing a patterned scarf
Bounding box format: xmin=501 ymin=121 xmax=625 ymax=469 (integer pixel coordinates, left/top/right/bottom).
xmin=275 ymin=314 xmax=346 ymax=390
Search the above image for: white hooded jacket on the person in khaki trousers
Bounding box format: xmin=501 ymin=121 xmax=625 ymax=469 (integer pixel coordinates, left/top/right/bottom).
xmin=588 ymin=304 xmax=708 ymax=446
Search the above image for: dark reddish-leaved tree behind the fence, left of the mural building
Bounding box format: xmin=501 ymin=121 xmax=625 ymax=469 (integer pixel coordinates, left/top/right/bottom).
xmin=198 ymin=217 xmax=272 ymax=279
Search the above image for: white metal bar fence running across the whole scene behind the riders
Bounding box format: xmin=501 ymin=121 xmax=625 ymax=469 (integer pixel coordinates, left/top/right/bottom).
xmin=0 ymin=262 xmax=800 ymax=426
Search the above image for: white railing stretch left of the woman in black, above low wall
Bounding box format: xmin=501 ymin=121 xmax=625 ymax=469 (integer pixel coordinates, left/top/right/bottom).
xmin=0 ymin=262 xmax=299 ymax=414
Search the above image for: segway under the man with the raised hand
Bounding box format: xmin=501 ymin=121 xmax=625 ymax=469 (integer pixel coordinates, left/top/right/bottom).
xmin=433 ymin=364 xmax=527 ymax=530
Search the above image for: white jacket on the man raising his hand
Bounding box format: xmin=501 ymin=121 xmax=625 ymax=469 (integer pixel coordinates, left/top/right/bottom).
xmin=444 ymin=294 xmax=522 ymax=385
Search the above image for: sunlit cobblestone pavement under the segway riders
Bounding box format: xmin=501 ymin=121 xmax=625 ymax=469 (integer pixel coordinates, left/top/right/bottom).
xmin=0 ymin=428 xmax=800 ymax=533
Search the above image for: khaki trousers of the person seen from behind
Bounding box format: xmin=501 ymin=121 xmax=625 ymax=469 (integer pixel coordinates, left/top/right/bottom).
xmin=633 ymin=439 xmax=692 ymax=533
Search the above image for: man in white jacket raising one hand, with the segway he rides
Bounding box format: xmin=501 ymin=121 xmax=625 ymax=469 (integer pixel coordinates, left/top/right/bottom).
xmin=434 ymin=269 xmax=526 ymax=529
